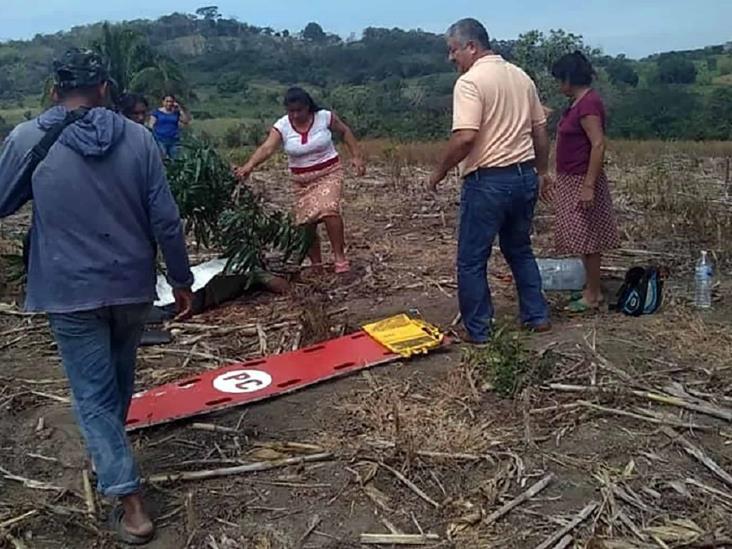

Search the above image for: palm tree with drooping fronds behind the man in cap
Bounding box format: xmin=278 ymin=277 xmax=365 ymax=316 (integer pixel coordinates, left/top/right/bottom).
xmin=92 ymin=23 xmax=191 ymax=97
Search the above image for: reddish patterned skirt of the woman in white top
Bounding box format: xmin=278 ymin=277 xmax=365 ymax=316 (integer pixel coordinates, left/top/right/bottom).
xmin=292 ymin=164 xmax=344 ymax=225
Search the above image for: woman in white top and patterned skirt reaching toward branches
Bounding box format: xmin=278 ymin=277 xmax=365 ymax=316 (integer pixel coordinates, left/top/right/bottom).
xmin=236 ymin=88 xmax=366 ymax=274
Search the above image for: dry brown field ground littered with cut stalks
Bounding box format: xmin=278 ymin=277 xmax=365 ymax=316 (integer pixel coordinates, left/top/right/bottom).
xmin=0 ymin=142 xmax=732 ymax=549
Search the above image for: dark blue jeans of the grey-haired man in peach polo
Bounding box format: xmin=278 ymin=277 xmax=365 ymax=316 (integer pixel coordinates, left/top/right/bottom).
xmin=458 ymin=168 xmax=549 ymax=343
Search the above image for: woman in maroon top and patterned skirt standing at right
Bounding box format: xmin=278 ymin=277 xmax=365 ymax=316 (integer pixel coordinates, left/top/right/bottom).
xmin=551 ymin=52 xmax=620 ymax=312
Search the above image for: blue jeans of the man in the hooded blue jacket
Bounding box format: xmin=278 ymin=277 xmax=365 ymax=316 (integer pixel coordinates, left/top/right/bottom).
xmin=49 ymin=304 xmax=150 ymax=497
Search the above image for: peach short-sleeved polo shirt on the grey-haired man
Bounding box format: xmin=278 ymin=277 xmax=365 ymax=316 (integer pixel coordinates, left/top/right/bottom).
xmin=452 ymin=55 xmax=546 ymax=176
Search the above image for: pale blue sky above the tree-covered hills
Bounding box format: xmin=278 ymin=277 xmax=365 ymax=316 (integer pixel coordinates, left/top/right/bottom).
xmin=0 ymin=0 xmax=732 ymax=57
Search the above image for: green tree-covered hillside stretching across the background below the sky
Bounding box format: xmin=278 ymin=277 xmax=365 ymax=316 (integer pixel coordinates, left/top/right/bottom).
xmin=0 ymin=9 xmax=732 ymax=142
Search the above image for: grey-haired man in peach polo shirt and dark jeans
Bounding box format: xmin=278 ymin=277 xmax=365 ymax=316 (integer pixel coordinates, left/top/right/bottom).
xmin=430 ymin=19 xmax=551 ymax=343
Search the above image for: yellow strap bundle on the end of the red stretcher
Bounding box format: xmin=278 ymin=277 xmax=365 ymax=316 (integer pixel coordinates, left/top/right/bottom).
xmin=363 ymin=314 xmax=445 ymax=358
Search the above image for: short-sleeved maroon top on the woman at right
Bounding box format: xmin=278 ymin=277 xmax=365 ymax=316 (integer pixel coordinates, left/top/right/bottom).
xmin=557 ymin=90 xmax=605 ymax=175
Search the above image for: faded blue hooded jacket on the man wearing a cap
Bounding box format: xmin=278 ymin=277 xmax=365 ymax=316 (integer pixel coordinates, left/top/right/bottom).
xmin=0 ymin=107 xmax=193 ymax=313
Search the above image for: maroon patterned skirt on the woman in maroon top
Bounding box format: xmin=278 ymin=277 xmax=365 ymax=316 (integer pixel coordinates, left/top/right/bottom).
xmin=554 ymin=173 xmax=620 ymax=255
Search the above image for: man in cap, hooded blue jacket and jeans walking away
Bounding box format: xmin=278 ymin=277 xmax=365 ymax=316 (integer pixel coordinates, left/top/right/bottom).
xmin=0 ymin=50 xmax=193 ymax=544
